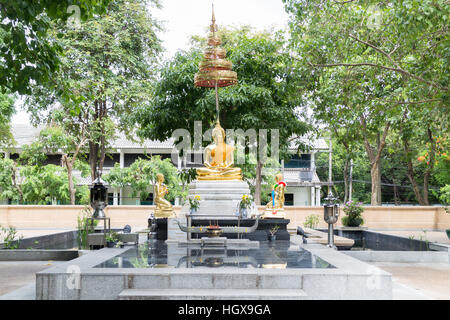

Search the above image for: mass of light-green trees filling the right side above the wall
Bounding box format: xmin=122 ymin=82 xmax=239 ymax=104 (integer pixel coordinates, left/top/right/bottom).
xmin=283 ymin=0 xmax=450 ymax=204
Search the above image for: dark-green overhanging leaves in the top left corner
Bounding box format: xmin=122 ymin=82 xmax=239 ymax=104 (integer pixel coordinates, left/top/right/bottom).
xmin=0 ymin=0 xmax=109 ymax=94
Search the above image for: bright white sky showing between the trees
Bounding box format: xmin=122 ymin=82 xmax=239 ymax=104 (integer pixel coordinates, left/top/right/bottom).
xmin=12 ymin=0 xmax=288 ymax=124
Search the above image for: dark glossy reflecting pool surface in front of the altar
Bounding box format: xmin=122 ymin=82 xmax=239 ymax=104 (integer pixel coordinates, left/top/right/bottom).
xmin=95 ymin=241 xmax=335 ymax=269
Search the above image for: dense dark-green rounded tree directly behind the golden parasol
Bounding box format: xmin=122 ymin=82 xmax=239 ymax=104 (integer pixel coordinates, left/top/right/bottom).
xmin=136 ymin=27 xmax=309 ymax=204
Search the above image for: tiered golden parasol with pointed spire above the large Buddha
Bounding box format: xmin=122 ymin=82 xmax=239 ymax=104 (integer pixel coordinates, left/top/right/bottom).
xmin=194 ymin=6 xmax=237 ymax=121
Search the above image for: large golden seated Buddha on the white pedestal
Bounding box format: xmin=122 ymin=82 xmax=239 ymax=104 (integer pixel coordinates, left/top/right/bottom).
xmin=197 ymin=121 xmax=242 ymax=180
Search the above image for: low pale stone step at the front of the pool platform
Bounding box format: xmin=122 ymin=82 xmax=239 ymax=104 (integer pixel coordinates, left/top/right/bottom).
xmin=119 ymin=289 xmax=308 ymax=300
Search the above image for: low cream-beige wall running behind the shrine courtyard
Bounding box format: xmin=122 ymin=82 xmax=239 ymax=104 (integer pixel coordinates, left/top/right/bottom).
xmin=0 ymin=205 xmax=450 ymax=230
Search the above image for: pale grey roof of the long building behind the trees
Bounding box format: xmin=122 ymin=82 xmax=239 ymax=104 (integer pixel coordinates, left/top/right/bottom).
xmin=5 ymin=124 xmax=328 ymax=151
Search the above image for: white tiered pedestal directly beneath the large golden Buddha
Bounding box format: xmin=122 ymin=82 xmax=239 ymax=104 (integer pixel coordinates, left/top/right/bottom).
xmin=180 ymin=180 xmax=256 ymax=219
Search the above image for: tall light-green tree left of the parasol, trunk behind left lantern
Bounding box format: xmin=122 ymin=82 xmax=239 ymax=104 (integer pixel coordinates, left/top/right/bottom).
xmin=23 ymin=0 xmax=162 ymax=180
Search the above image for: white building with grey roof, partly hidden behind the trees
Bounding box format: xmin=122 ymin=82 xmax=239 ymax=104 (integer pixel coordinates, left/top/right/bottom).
xmin=3 ymin=124 xmax=330 ymax=206
